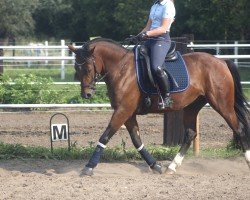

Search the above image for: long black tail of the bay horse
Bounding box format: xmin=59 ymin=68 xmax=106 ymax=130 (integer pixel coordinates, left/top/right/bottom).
xmin=225 ymin=60 xmax=250 ymax=148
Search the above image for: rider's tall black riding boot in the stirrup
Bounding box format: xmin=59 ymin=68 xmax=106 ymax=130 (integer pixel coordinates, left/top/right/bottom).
xmin=156 ymin=67 xmax=173 ymax=109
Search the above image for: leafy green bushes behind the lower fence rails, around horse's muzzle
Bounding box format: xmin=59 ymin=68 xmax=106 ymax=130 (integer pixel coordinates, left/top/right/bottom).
xmin=0 ymin=74 xmax=109 ymax=104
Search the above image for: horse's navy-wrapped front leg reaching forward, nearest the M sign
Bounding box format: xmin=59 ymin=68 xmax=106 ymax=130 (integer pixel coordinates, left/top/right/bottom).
xmin=82 ymin=110 xmax=132 ymax=176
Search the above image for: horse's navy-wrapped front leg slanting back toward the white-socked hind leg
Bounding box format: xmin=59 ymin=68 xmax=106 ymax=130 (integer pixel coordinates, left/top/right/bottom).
xmin=125 ymin=115 xmax=165 ymax=174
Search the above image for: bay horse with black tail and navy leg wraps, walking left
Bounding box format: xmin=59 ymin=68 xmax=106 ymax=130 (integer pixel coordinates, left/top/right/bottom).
xmin=68 ymin=39 xmax=250 ymax=175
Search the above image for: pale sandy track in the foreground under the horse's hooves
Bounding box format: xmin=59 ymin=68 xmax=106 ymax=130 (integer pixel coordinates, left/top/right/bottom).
xmin=0 ymin=158 xmax=250 ymax=200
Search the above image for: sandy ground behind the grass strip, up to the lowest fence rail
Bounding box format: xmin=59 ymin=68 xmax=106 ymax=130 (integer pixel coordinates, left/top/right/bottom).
xmin=0 ymin=108 xmax=232 ymax=147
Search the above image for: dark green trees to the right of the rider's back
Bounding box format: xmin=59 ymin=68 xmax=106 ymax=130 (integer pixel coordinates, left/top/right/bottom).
xmin=173 ymin=0 xmax=250 ymax=40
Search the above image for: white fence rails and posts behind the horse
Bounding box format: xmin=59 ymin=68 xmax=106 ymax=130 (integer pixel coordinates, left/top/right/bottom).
xmin=0 ymin=40 xmax=250 ymax=108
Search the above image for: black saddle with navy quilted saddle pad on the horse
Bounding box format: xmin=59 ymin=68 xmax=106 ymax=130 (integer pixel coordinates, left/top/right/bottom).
xmin=134 ymin=42 xmax=189 ymax=95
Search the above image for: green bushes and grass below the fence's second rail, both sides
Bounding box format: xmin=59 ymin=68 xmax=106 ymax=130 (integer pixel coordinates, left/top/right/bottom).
xmin=0 ymin=67 xmax=250 ymax=104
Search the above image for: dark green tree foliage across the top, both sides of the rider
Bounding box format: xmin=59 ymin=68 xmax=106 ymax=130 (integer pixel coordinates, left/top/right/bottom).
xmin=0 ymin=0 xmax=250 ymax=41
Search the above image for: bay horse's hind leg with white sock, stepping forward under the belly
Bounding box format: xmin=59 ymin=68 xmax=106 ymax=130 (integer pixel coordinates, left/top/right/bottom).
xmin=167 ymin=99 xmax=205 ymax=174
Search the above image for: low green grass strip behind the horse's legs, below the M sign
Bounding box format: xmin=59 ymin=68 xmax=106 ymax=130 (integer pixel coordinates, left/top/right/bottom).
xmin=0 ymin=143 xmax=242 ymax=161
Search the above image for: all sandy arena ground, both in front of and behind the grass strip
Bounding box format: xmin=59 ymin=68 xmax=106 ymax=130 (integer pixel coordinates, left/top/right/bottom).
xmin=0 ymin=109 xmax=250 ymax=200
